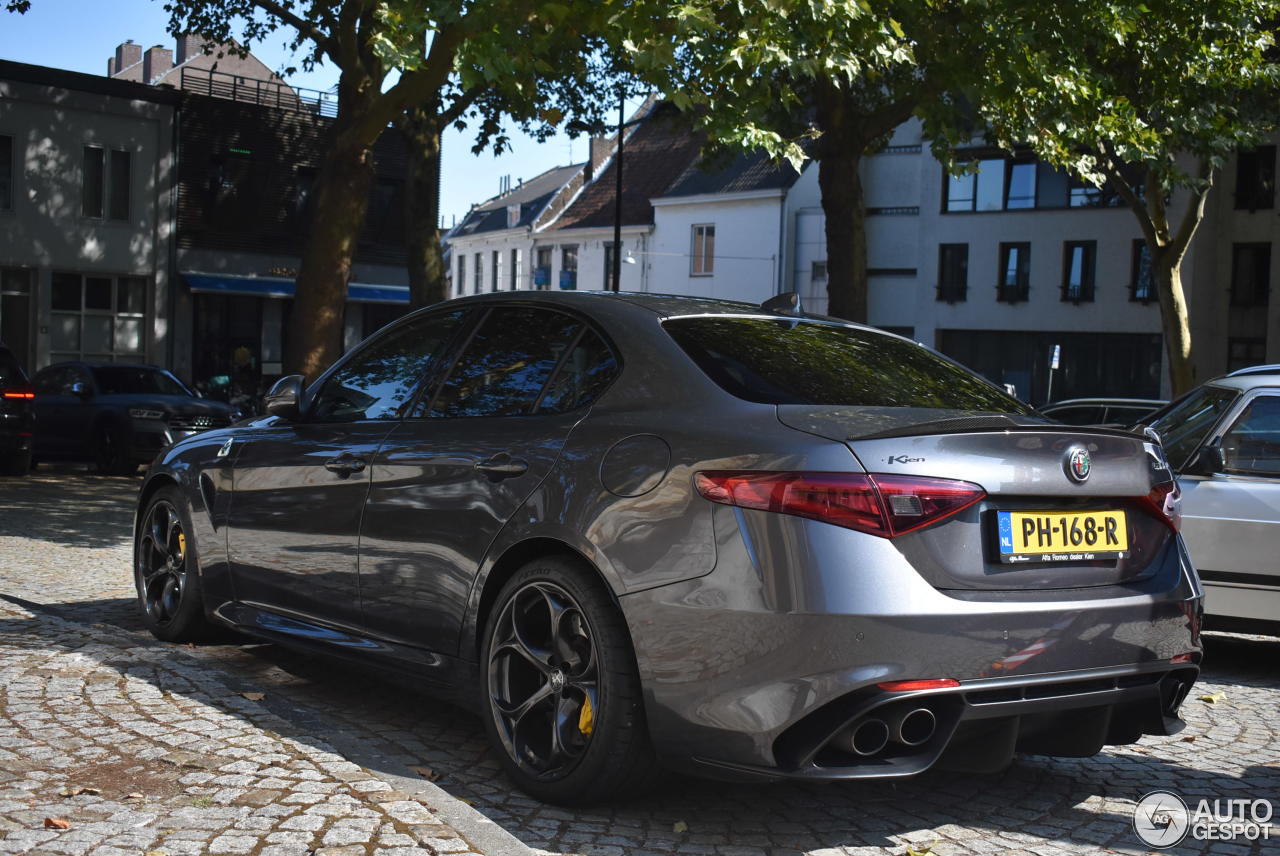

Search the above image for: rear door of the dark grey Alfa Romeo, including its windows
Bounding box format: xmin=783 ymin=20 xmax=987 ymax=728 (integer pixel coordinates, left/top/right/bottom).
xmin=360 ymin=306 xmax=617 ymax=654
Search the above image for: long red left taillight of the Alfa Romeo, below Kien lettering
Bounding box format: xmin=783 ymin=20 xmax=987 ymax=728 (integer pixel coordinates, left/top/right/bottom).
xmin=694 ymin=472 xmax=987 ymax=537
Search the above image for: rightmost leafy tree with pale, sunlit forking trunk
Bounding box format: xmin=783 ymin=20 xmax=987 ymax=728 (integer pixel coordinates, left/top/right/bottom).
xmin=957 ymin=0 xmax=1280 ymax=394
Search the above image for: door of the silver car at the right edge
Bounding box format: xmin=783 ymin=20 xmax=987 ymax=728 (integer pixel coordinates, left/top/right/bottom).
xmin=1179 ymin=389 xmax=1280 ymax=621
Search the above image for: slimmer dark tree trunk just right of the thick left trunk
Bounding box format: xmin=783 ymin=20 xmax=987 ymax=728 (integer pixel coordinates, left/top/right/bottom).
xmin=399 ymin=102 xmax=448 ymax=308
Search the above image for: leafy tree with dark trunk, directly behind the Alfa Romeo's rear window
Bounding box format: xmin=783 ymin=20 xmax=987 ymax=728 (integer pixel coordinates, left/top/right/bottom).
xmin=620 ymin=0 xmax=984 ymax=321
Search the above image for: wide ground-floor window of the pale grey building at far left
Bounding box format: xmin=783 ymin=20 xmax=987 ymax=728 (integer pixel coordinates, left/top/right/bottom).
xmin=49 ymin=273 xmax=147 ymax=362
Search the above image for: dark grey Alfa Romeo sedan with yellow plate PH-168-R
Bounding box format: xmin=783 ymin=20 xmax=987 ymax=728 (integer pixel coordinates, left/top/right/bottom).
xmin=134 ymin=292 xmax=1202 ymax=802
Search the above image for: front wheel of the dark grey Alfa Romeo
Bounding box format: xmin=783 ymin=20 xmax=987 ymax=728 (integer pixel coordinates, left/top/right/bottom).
xmin=133 ymin=487 xmax=212 ymax=642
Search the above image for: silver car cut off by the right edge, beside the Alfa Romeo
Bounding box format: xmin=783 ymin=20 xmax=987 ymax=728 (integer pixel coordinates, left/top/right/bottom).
xmin=1147 ymin=366 xmax=1280 ymax=635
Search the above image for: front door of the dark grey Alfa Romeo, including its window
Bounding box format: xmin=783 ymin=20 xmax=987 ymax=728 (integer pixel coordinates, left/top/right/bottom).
xmin=228 ymin=312 xmax=462 ymax=627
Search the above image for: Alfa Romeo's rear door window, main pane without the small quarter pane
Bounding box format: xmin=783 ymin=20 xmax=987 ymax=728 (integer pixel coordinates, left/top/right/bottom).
xmin=430 ymin=307 xmax=582 ymax=418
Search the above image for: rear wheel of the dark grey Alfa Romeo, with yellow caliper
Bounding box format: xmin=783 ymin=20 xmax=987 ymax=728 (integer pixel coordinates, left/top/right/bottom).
xmin=481 ymin=557 xmax=658 ymax=805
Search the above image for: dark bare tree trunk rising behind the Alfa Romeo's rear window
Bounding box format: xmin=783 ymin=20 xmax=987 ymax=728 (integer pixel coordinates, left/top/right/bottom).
xmin=818 ymin=146 xmax=867 ymax=322
